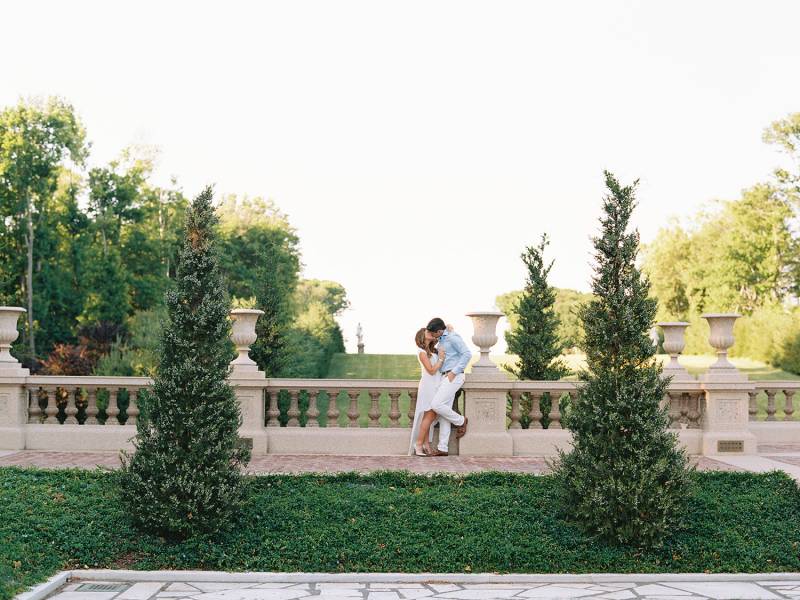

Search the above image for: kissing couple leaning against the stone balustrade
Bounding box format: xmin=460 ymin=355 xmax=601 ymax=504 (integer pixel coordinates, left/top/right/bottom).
xmin=409 ymin=317 xmax=472 ymax=456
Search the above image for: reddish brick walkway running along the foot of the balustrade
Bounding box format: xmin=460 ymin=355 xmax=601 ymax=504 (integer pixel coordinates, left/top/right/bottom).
xmin=0 ymin=444 xmax=800 ymax=478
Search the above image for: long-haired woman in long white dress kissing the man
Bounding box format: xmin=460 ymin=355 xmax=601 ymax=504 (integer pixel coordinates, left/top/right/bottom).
xmin=408 ymin=328 xmax=444 ymax=456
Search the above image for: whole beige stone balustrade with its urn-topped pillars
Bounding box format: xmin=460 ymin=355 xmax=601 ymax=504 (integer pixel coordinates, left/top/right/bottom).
xmin=0 ymin=307 xmax=800 ymax=456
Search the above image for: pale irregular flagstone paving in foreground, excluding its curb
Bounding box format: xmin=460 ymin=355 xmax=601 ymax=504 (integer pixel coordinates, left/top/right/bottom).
xmin=37 ymin=576 xmax=800 ymax=600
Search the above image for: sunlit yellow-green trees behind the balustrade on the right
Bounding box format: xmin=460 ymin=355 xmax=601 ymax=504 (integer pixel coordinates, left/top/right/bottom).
xmin=496 ymin=113 xmax=800 ymax=373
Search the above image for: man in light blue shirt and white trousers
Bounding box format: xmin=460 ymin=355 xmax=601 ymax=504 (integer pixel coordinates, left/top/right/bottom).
xmin=427 ymin=317 xmax=472 ymax=456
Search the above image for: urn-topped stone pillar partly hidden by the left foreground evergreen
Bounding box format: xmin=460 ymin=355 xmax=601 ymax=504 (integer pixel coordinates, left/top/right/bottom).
xmin=229 ymin=308 xmax=267 ymax=456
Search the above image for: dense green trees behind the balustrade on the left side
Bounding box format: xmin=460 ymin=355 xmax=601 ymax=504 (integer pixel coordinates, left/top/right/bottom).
xmin=0 ymin=98 xmax=348 ymax=377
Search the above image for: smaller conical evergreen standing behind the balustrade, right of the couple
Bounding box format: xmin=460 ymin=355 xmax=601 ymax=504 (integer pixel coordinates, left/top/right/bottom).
xmin=505 ymin=234 xmax=569 ymax=380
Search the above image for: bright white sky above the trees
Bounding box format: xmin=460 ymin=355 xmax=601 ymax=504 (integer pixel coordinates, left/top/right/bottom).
xmin=0 ymin=0 xmax=800 ymax=353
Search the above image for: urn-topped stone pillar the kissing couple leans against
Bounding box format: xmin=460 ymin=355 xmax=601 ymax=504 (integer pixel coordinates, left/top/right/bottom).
xmin=458 ymin=312 xmax=514 ymax=456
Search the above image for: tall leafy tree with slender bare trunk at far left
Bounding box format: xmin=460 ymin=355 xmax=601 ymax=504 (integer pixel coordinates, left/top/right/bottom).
xmin=0 ymin=98 xmax=86 ymax=357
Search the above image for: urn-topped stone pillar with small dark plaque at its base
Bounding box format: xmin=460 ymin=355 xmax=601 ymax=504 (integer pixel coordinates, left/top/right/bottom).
xmin=700 ymin=313 xmax=757 ymax=455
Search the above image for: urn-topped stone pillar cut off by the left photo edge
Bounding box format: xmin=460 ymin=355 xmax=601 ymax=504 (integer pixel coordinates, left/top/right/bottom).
xmin=0 ymin=306 xmax=30 ymax=450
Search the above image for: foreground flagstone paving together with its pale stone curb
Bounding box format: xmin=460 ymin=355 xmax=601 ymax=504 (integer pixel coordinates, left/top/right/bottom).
xmin=25 ymin=572 xmax=800 ymax=600
